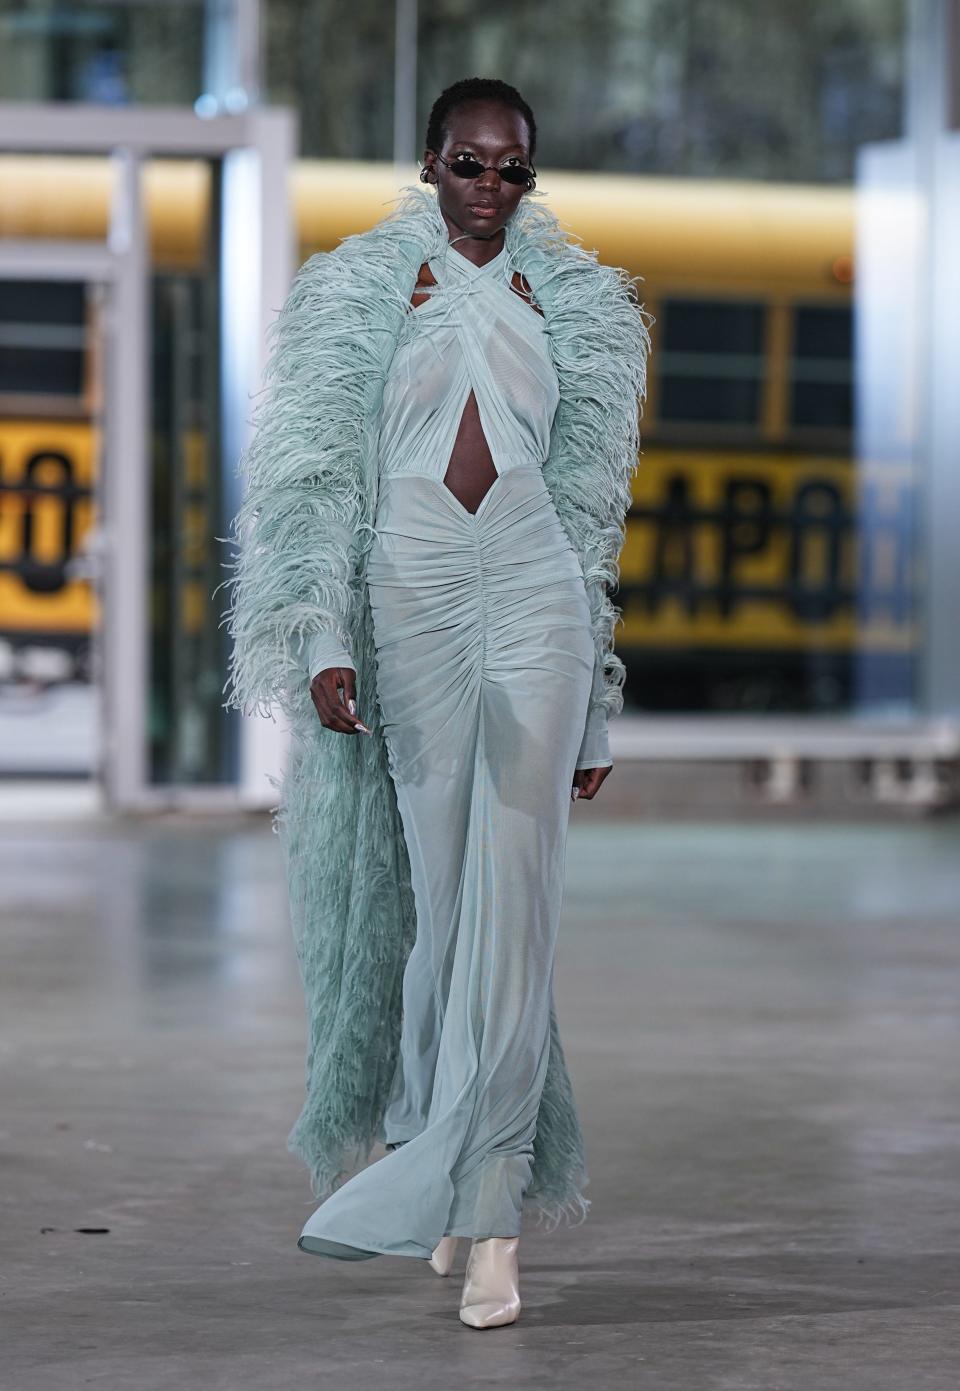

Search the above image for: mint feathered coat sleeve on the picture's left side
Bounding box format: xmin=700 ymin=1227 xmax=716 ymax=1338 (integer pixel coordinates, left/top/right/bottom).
xmin=227 ymin=255 xmax=363 ymax=714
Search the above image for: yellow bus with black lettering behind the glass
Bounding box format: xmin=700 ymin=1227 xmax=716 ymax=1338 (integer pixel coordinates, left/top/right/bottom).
xmin=0 ymin=157 xmax=915 ymax=712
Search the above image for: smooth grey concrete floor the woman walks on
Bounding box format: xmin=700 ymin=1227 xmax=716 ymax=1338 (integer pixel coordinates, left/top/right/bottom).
xmin=0 ymin=807 xmax=960 ymax=1391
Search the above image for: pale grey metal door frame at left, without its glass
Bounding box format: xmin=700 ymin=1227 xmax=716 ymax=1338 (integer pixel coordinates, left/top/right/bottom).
xmin=0 ymin=102 xmax=298 ymax=810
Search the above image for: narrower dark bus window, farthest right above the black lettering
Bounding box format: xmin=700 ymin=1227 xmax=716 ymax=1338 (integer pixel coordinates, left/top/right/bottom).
xmin=790 ymin=305 xmax=853 ymax=431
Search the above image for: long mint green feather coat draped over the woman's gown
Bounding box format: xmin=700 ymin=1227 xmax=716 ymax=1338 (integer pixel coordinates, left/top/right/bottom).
xmin=227 ymin=186 xmax=650 ymax=1225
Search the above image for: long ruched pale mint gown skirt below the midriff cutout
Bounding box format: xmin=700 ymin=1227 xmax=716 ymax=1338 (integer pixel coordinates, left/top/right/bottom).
xmin=299 ymin=465 xmax=594 ymax=1260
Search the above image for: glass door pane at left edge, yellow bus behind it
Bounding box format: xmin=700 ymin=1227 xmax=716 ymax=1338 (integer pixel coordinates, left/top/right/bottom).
xmin=0 ymin=271 xmax=103 ymax=778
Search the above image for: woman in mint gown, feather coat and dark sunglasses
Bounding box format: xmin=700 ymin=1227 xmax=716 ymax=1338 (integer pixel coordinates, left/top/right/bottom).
xmin=230 ymin=78 xmax=650 ymax=1328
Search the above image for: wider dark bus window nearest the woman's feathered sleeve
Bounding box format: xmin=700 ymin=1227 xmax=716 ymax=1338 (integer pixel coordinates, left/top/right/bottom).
xmin=658 ymin=299 xmax=764 ymax=433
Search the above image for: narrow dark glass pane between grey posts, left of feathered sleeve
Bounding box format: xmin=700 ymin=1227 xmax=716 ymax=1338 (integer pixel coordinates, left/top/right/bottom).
xmin=149 ymin=160 xmax=234 ymax=785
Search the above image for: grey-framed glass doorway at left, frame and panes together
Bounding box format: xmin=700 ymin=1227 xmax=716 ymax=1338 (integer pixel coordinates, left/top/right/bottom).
xmin=0 ymin=92 xmax=296 ymax=810
